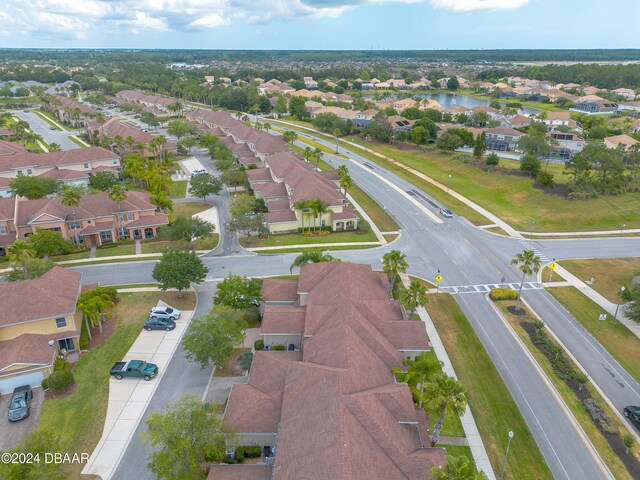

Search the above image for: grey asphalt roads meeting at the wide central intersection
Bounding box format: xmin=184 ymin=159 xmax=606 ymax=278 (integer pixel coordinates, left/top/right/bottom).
xmin=77 ymin=122 xmax=640 ymax=479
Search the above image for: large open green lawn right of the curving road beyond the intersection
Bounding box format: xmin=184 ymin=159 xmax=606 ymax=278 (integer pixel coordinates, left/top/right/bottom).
xmin=272 ymin=118 xmax=640 ymax=232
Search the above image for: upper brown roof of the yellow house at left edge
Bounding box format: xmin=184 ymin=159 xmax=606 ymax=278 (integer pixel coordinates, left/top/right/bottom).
xmin=0 ymin=267 xmax=82 ymax=326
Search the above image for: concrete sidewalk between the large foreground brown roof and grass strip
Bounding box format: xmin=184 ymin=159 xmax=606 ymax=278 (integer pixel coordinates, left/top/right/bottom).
xmin=400 ymin=274 xmax=496 ymax=480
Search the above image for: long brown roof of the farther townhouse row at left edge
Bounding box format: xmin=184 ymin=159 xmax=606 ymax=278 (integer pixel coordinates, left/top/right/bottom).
xmin=0 ymin=147 xmax=120 ymax=172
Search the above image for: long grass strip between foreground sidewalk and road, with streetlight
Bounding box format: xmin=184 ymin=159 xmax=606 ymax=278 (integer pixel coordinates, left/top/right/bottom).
xmin=427 ymin=293 xmax=553 ymax=480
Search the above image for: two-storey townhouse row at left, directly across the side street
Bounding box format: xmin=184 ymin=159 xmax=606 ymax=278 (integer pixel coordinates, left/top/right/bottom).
xmin=0 ymin=191 xmax=169 ymax=256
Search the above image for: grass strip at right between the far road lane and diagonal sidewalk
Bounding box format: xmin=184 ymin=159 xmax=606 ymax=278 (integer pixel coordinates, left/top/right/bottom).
xmin=547 ymin=287 xmax=640 ymax=382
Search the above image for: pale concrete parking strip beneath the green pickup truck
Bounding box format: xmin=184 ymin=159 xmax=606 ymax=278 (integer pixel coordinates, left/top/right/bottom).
xmin=82 ymin=302 xmax=193 ymax=480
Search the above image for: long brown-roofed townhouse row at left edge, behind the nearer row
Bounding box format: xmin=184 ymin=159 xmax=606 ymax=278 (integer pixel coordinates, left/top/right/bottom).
xmin=0 ymin=147 xmax=120 ymax=197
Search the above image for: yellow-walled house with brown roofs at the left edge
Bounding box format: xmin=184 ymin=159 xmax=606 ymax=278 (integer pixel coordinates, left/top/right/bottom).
xmin=0 ymin=266 xmax=82 ymax=394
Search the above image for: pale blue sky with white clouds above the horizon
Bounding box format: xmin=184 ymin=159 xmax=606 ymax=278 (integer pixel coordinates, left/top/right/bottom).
xmin=0 ymin=0 xmax=640 ymax=50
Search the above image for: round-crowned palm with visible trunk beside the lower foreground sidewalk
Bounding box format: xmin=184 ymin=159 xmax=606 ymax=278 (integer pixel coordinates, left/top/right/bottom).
xmin=424 ymin=374 xmax=467 ymax=447
